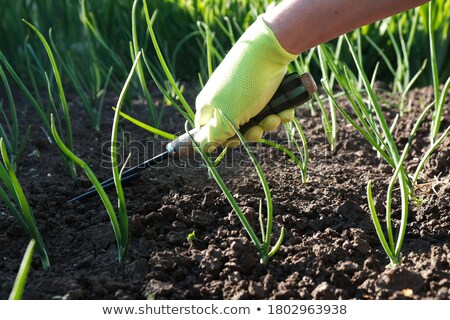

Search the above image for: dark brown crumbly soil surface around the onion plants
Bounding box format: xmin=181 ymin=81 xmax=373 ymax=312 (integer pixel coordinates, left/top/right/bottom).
xmin=0 ymin=88 xmax=450 ymax=299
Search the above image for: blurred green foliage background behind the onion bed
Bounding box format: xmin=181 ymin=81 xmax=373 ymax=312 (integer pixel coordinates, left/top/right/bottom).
xmin=0 ymin=0 xmax=450 ymax=85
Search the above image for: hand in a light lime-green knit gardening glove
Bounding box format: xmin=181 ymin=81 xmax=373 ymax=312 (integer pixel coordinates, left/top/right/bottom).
xmin=194 ymin=15 xmax=296 ymax=152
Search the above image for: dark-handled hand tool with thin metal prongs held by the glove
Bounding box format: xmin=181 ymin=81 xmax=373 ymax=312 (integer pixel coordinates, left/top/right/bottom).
xmin=68 ymin=73 xmax=317 ymax=203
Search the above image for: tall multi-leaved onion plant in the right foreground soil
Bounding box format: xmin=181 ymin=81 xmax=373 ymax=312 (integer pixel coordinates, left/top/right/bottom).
xmin=322 ymin=37 xmax=450 ymax=264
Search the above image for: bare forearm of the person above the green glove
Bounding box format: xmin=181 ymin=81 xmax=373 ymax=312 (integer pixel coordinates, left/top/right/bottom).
xmin=264 ymin=0 xmax=429 ymax=54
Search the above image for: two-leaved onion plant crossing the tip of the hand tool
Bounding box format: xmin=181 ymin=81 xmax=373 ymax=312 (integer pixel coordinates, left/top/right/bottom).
xmin=51 ymin=52 xmax=141 ymax=262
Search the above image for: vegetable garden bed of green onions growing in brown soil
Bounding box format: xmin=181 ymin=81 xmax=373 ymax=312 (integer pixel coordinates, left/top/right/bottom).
xmin=0 ymin=0 xmax=450 ymax=299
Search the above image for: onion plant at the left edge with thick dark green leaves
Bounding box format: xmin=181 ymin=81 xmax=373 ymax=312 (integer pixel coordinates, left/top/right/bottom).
xmin=0 ymin=138 xmax=50 ymax=269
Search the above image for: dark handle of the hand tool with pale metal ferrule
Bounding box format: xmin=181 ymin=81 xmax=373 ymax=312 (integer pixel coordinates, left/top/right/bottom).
xmin=167 ymin=73 xmax=317 ymax=158
